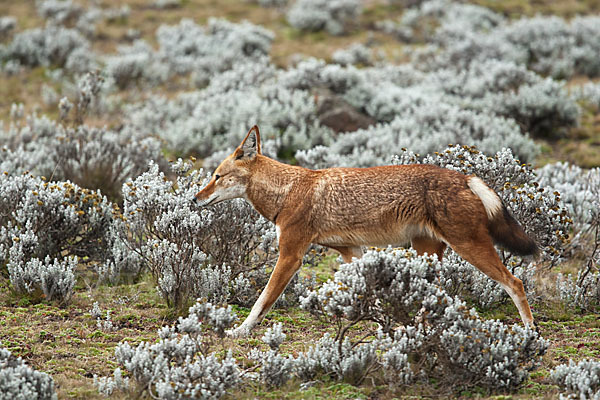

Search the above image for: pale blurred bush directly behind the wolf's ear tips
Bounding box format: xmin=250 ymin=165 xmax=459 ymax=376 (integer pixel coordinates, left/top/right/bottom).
xmin=128 ymin=61 xmax=332 ymax=158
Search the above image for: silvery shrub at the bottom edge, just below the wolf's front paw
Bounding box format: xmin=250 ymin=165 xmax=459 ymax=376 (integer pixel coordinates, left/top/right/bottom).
xmin=94 ymin=302 xmax=240 ymax=400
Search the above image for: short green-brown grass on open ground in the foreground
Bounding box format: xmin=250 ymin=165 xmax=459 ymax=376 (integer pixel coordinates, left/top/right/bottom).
xmin=0 ymin=256 xmax=600 ymax=399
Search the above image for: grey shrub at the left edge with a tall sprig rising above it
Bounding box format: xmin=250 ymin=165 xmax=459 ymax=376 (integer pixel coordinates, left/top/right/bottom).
xmin=0 ymin=74 xmax=164 ymax=200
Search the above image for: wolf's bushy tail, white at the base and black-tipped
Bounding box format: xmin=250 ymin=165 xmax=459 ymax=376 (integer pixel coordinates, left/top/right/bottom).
xmin=468 ymin=176 xmax=540 ymax=257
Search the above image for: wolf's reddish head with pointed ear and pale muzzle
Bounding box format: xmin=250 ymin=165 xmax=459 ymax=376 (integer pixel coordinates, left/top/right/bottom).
xmin=192 ymin=125 xmax=261 ymax=207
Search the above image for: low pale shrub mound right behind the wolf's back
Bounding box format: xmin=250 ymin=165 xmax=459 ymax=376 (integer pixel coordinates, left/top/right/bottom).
xmin=296 ymin=103 xmax=537 ymax=168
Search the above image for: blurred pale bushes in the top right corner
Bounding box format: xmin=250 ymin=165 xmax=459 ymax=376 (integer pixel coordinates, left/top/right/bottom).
xmin=394 ymin=0 xmax=600 ymax=78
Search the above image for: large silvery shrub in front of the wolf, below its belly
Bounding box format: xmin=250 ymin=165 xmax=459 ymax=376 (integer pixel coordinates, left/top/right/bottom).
xmin=296 ymin=248 xmax=548 ymax=388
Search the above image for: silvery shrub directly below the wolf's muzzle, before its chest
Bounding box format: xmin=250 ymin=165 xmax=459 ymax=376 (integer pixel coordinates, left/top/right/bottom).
xmin=114 ymin=159 xmax=275 ymax=308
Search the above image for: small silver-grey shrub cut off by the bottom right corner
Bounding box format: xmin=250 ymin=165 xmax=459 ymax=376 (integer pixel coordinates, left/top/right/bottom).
xmin=550 ymin=360 xmax=600 ymax=400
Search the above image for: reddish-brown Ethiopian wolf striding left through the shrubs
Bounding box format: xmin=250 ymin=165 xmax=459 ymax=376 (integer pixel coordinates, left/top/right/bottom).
xmin=193 ymin=126 xmax=538 ymax=336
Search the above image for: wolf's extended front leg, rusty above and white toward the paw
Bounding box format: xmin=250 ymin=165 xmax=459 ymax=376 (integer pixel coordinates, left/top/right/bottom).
xmin=227 ymin=232 xmax=310 ymax=337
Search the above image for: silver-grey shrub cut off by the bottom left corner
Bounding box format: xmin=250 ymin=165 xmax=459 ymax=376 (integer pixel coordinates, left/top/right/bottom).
xmin=0 ymin=348 xmax=57 ymax=400
